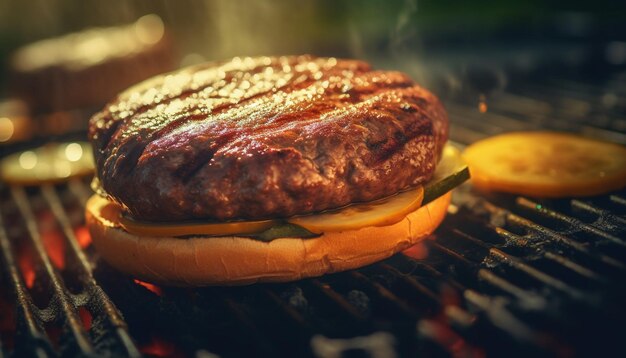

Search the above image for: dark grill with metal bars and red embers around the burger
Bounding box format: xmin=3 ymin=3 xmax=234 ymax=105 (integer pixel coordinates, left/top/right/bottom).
xmin=0 ymin=65 xmax=626 ymax=357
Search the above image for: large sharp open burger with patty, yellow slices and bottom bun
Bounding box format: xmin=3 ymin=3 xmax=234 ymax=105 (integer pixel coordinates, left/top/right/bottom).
xmin=86 ymin=56 xmax=468 ymax=286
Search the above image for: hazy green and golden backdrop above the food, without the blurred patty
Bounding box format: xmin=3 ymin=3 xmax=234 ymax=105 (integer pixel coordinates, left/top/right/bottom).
xmin=0 ymin=0 xmax=626 ymax=87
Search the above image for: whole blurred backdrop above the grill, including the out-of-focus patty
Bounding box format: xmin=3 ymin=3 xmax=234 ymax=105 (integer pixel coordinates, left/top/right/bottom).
xmin=0 ymin=0 xmax=626 ymax=148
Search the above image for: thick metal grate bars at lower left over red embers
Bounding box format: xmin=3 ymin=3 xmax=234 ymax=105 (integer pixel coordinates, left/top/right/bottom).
xmin=0 ymin=183 xmax=140 ymax=356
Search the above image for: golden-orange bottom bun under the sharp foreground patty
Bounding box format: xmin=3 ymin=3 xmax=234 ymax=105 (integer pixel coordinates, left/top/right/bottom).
xmin=86 ymin=193 xmax=451 ymax=286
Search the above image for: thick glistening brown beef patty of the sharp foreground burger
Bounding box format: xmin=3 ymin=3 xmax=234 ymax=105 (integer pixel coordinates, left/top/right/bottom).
xmin=89 ymin=56 xmax=448 ymax=221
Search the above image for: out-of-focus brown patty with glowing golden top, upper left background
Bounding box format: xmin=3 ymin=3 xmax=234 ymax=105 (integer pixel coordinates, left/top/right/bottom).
xmin=9 ymin=15 xmax=175 ymax=112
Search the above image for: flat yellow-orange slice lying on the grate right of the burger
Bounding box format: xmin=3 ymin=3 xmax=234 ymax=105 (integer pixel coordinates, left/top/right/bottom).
xmin=463 ymin=132 xmax=626 ymax=198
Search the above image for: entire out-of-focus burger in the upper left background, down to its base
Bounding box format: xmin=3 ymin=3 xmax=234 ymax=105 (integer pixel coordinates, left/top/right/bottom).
xmin=0 ymin=14 xmax=178 ymax=142
